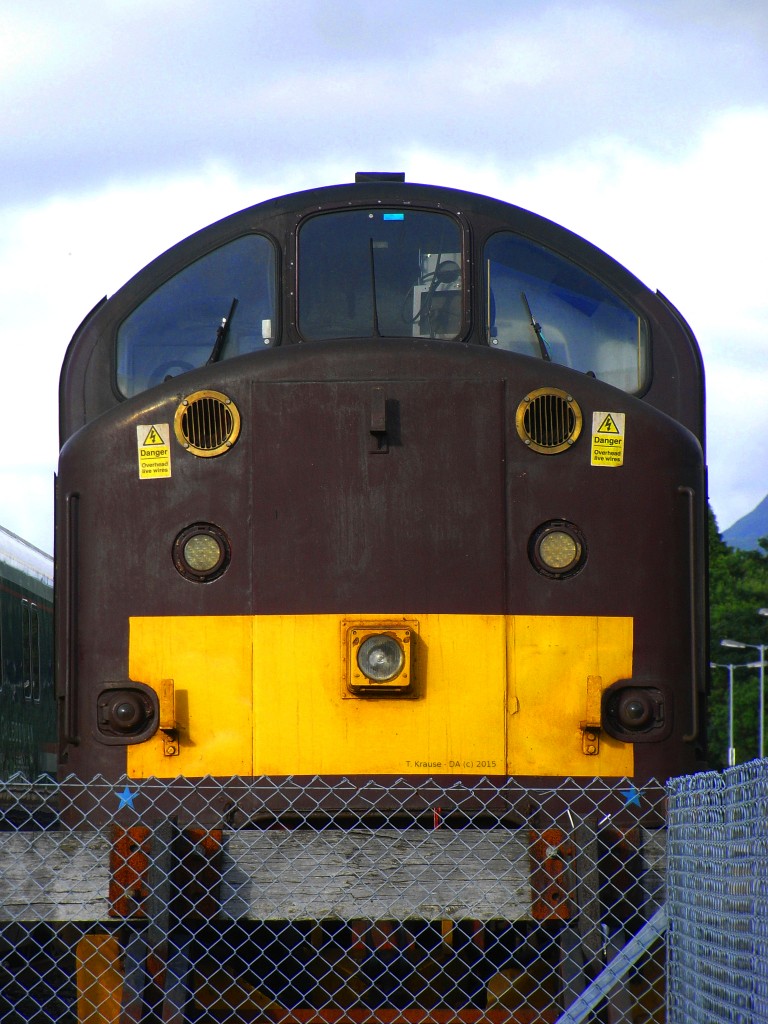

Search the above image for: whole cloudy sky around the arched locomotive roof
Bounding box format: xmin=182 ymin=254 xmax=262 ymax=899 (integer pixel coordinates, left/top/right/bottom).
xmin=0 ymin=0 xmax=768 ymax=551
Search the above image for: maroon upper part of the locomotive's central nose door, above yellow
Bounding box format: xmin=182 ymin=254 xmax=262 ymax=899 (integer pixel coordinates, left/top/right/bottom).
xmin=252 ymin=380 xmax=506 ymax=614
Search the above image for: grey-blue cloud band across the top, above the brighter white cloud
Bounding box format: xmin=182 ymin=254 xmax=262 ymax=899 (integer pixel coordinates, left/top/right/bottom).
xmin=0 ymin=0 xmax=768 ymax=202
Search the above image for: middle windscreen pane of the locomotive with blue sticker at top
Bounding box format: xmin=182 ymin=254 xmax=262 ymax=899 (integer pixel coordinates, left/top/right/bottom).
xmin=298 ymin=208 xmax=463 ymax=341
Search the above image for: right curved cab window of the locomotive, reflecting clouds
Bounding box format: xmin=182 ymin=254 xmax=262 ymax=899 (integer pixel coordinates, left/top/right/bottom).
xmin=484 ymin=232 xmax=648 ymax=393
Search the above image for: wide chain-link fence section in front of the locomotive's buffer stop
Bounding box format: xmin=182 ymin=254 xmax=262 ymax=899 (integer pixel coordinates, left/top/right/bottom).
xmin=0 ymin=778 xmax=666 ymax=1024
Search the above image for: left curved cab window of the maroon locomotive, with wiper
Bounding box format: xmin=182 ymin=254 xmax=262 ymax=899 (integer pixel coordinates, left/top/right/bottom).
xmin=117 ymin=234 xmax=276 ymax=397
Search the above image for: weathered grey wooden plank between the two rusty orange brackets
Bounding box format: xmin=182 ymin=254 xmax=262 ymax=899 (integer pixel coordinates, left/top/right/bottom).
xmin=222 ymin=829 xmax=530 ymax=921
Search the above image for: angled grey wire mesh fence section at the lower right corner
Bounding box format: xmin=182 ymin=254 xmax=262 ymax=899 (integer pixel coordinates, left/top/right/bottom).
xmin=668 ymin=761 xmax=768 ymax=1024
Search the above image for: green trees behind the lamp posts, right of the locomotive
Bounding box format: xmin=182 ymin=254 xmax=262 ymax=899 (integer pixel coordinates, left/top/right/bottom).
xmin=708 ymin=510 xmax=768 ymax=768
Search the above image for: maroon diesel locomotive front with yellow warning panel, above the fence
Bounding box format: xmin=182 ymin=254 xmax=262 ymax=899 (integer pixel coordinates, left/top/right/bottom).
xmin=56 ymin=174 xmax=707 ymax=786
